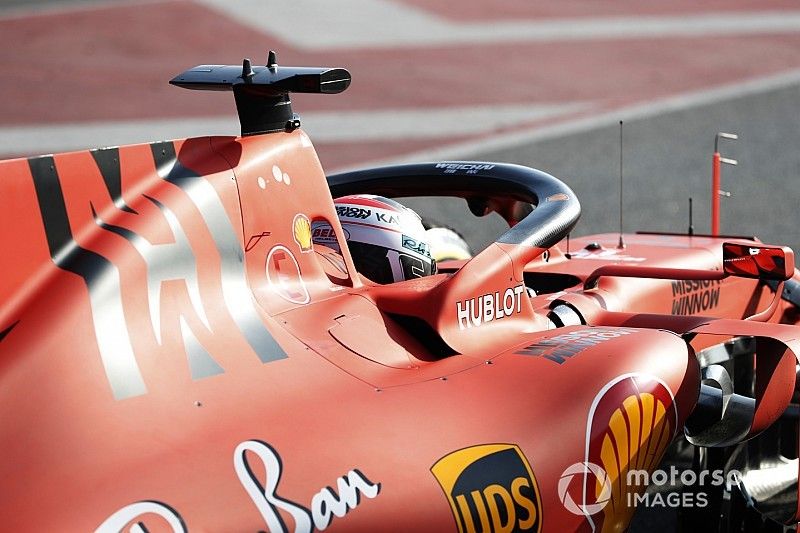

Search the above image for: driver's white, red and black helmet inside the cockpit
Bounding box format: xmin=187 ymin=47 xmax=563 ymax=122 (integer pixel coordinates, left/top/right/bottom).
xmin=334 ymin=194 xmax=436 ymax=283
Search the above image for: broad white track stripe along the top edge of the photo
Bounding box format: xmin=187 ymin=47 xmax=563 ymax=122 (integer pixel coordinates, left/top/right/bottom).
xmin=197 ymin=0 xmax=800 ymax=50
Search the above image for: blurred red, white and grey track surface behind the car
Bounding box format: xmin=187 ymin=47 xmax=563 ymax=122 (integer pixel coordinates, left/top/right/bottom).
xmin=0 ymin=0 xmax=800 ymax=249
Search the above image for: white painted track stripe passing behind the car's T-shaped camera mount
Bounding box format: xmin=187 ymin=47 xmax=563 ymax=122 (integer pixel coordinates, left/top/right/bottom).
xmin=0 ymin=101 xmax=589 ymax=154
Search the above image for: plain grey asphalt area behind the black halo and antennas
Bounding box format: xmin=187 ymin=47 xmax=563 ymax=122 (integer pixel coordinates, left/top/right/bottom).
xmin=407 ymin=80 xmax=800 ymax=256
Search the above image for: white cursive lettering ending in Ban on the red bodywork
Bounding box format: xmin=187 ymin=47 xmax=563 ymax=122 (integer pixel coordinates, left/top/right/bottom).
xmin=97 ymin=440 xmax=381 ymax=533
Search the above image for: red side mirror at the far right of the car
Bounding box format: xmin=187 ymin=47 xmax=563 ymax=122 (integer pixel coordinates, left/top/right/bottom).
xmin=722 ymin=242 xmax=794 ymax=281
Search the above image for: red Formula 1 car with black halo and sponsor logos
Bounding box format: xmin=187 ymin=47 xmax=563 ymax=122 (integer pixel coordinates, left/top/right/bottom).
xmin=0 ymin=55 xmax=800 ymax=533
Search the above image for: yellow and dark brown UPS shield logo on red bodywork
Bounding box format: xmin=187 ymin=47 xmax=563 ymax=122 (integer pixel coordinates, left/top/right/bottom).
xmin=431 ymin=444 xmax=542 ymax=533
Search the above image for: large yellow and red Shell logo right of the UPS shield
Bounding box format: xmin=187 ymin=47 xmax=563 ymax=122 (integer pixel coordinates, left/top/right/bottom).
xmin=559 ymin=374 xmax=678 ymax=531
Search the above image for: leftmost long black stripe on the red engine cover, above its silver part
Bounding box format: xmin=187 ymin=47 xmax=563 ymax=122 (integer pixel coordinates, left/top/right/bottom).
xmin=28 ymin=156 xmax=113 ymax=285
